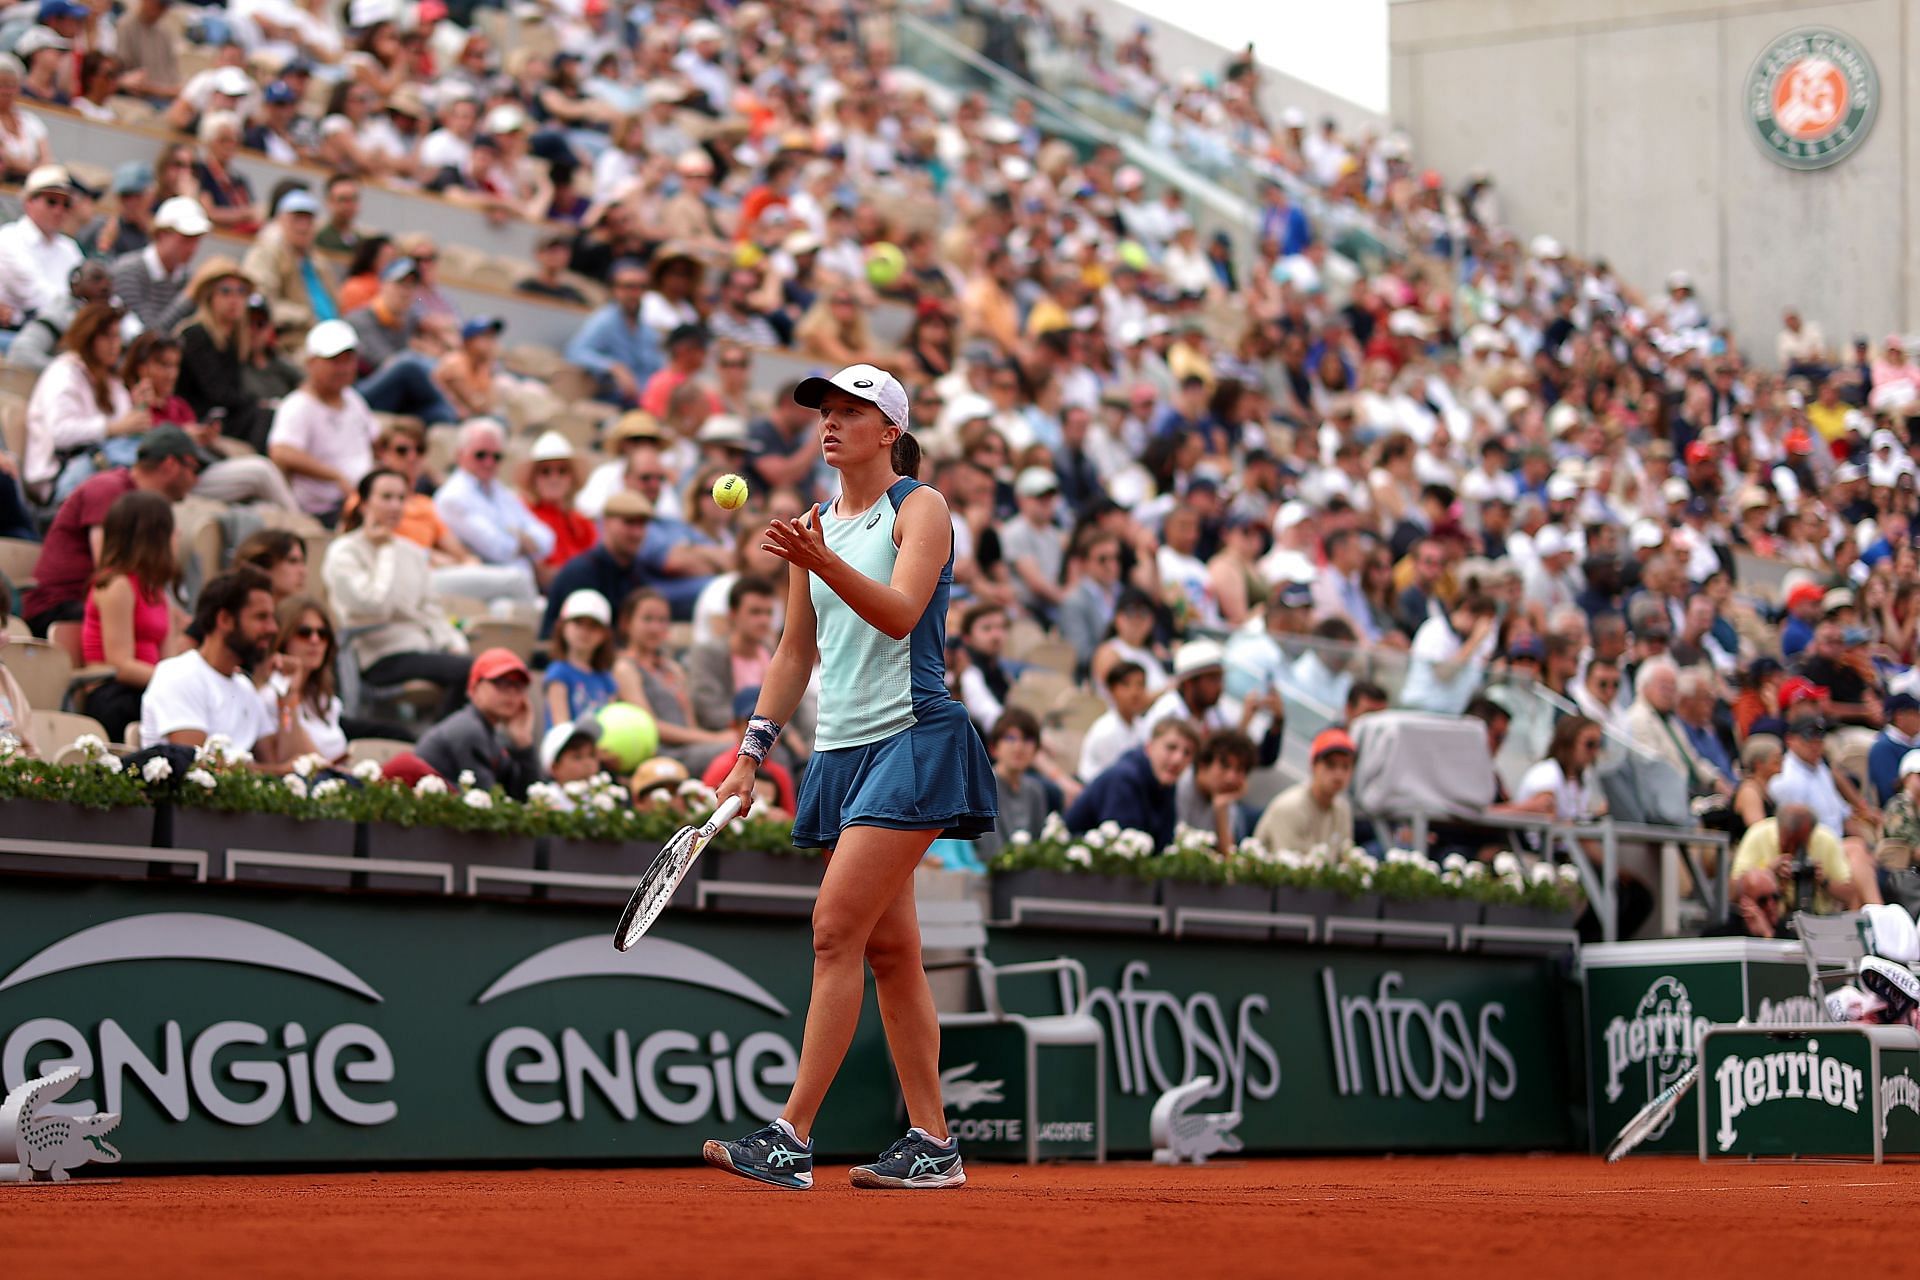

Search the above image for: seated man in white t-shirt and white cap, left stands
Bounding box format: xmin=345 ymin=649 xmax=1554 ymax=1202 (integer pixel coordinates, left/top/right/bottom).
xmin=267 ymin=320 xmax=380 ymax=520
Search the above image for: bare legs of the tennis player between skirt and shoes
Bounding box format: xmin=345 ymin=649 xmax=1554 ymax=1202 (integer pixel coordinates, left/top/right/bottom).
xmin=781 ymin=827 xmax=947 ymax=1140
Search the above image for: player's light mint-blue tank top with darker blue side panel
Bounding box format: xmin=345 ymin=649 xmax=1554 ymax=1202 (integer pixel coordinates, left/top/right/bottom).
xmin=808 ymin=480 xmax=954 ymax=750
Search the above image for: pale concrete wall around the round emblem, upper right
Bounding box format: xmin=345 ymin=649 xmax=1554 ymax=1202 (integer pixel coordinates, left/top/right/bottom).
xmin=1388 ymin=0 xmax=1920 ymax=361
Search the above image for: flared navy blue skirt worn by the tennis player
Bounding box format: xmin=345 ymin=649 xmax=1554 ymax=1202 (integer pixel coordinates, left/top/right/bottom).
xmin=793 ymin=699 xmax=998 ymax=848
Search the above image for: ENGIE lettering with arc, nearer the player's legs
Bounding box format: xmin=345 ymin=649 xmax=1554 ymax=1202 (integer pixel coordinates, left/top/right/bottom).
xmin=474 ymin=933 xmax=801 ymax=1125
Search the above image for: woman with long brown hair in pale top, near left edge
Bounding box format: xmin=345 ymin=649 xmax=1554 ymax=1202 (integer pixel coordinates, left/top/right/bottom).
xmin=21 ymin=301 xmax=154 ymax=505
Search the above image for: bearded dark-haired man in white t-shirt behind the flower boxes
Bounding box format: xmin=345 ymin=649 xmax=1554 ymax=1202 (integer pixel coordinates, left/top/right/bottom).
xmin=140 ymin=566 xmax=282 ymax=764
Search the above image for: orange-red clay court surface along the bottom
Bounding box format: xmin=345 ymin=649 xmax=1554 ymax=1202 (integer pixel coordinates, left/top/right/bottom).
xmin=11 ymin=1155 xmax=1920 ymax=1280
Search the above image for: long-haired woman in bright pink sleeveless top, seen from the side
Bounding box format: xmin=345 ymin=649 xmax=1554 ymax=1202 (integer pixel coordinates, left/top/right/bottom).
xmin=81 ymin=489 xmax=179 ymax=741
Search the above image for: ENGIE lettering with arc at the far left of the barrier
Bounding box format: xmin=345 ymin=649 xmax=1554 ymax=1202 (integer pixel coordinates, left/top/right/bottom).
xmin=0 ymin=912 xmax=399 ymax=1125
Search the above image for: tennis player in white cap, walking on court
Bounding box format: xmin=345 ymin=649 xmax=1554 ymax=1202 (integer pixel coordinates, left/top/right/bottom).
xmin=705 ymin=365 xmax=995 ymax=1190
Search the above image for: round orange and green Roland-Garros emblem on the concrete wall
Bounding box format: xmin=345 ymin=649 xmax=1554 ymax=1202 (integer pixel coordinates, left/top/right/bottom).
xmin=1745 ymin=27 xmax=1880 ymax=169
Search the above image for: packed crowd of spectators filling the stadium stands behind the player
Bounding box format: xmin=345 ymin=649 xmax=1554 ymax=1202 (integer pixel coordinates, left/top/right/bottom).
xmin=0 ymin=0 xmax=1920 ymax=940
